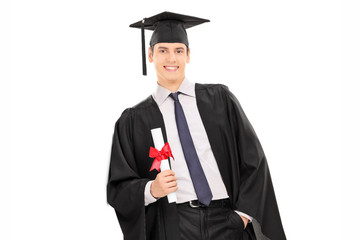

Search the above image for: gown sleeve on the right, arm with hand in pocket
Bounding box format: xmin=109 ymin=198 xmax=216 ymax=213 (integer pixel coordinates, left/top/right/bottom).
xmin=224 ymin=86 xmax=286 ymax=240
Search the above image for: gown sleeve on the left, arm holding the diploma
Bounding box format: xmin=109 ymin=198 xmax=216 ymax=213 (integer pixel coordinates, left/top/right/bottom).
xmin=107 ymin=109 xmax=149 ymax=240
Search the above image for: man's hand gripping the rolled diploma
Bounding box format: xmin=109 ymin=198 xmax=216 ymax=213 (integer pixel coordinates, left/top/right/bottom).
xmin=150 ymin=170 xmax=178 ymax=198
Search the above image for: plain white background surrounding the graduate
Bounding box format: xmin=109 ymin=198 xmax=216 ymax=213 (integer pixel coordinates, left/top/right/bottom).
xmin=0 ymin=0 xmax=360 ymax=240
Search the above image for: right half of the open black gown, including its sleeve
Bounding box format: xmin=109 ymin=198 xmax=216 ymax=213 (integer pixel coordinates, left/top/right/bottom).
xmin=196 ymin=84 xmax=286 ymax=240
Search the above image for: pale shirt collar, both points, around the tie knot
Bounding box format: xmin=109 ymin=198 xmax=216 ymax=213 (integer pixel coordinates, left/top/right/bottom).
xmin=152 ymin=78 xmax=195 ymax=106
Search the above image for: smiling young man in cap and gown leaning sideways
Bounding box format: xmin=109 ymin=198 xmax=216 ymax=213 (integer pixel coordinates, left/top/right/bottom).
xmin=107 ymin=12 xmax=286 ymax=240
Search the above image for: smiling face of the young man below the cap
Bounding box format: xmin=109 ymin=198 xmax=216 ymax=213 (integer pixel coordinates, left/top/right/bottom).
xmin=149 ymin=43 xmax=190 ymax=84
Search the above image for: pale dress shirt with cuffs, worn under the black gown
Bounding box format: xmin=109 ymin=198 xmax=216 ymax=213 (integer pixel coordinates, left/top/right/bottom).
xmin=144 ymin=78 xmax=252 ymax=221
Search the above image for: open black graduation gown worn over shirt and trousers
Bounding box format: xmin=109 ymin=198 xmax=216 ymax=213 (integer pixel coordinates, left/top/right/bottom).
xmin=107 ymin=84 xmax=286 ymax=240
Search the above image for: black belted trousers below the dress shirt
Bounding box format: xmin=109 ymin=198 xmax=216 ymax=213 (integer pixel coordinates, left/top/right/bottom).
xmin=177 ymin=204 xmax=256 ymax=240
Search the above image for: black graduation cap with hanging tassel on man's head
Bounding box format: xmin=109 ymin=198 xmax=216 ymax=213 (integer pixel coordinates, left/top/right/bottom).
xmin=130 ymin=12 xmax=210 ymax=75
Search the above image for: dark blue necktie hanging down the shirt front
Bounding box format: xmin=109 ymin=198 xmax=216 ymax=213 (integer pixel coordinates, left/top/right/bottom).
xmin=170 ymin=92 xmax=213 ymax=206
